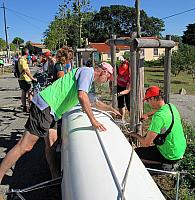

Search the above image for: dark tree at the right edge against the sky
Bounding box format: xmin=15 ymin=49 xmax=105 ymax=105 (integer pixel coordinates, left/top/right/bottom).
xmin=182 ymin=23 xmax=195 ymax=46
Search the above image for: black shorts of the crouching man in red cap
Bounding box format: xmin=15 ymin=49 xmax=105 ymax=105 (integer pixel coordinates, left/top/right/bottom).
xmin=135 ymin=146 xmax=178 ymax=164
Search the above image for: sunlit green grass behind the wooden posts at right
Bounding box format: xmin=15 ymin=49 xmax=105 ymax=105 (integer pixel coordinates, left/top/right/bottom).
xmin=144 ymin=67 xmax=195 ymax=95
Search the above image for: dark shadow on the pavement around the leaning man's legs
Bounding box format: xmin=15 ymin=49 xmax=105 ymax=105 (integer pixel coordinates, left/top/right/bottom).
xmin=0 ymin=114 xmax=61 ymax=200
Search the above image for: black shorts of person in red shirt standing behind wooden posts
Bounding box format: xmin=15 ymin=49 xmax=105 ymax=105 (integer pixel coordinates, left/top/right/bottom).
xmin=117 ymin=85 xmax=130 ymax=111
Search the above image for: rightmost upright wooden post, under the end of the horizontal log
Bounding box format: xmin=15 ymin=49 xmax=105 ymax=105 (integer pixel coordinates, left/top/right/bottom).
xmin=164 ymin=35 xmax=171 ymax=103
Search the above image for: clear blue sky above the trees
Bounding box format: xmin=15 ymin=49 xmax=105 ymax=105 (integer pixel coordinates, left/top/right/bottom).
xmin=0 ymin=0 xmax=195 ymax=42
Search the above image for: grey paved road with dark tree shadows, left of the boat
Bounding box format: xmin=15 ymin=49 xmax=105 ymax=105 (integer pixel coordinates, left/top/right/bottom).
xmin=0 ymin=71 xmax=60 ymax=200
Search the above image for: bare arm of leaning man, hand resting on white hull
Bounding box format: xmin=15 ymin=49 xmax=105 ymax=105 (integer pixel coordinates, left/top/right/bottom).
xmin=78 ymin=91 xmax=106 ymax=131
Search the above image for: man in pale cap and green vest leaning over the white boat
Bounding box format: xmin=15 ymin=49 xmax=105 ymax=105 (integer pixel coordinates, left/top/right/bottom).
xmin=0 ymin=62 xmax=120 ymax=182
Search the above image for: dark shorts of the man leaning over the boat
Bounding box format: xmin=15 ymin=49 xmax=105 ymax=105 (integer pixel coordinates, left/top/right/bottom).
xmin=25 ymin=103 xmax=57 ymax=137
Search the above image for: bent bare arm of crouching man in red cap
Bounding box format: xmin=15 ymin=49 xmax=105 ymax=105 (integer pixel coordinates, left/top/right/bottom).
xmin=131 ymin=131 xmax=157 ymax=147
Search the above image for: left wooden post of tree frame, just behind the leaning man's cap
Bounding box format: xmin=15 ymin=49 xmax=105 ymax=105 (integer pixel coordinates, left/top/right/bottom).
xmin=111 ymin=35 xmax=117 ymax=108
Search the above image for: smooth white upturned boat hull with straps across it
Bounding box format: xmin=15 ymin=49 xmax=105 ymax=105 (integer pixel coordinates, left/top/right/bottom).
xmin=61 ymin=106 xmax=165 ymax=200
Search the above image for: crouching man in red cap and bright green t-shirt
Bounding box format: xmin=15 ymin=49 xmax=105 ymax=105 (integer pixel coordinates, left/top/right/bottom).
xmin=131 ymin=86 xmax=186 ymax=166
